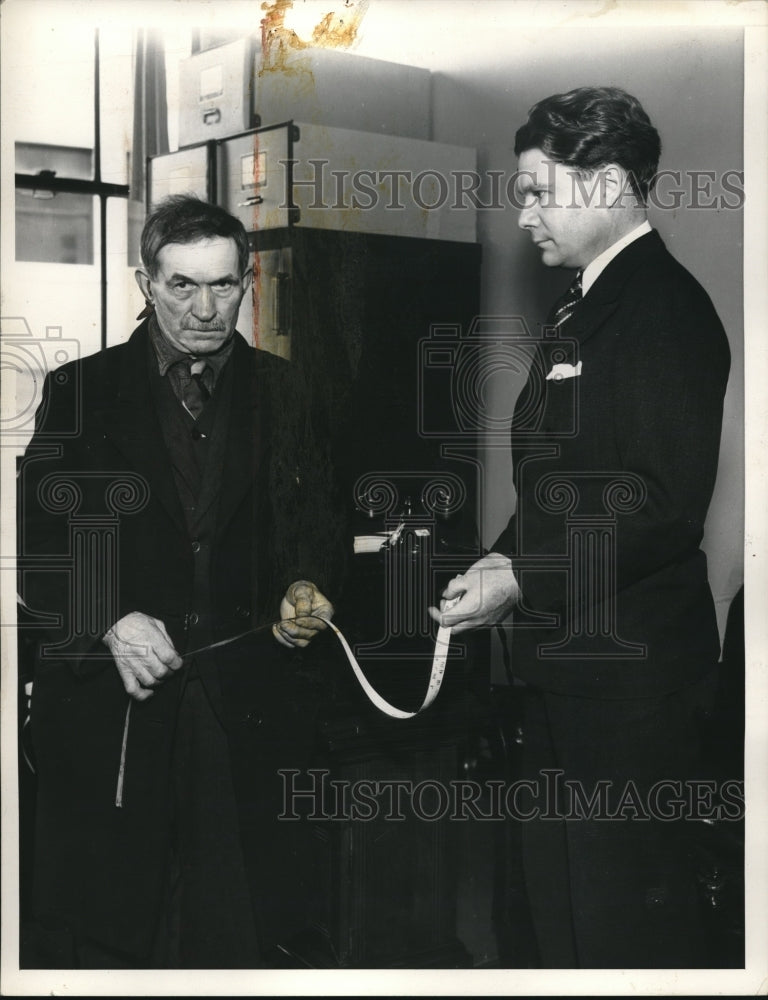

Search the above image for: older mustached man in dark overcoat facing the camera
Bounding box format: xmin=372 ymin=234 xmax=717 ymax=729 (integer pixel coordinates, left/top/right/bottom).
xmin=19 ymin=196 xmax=333 ymax=968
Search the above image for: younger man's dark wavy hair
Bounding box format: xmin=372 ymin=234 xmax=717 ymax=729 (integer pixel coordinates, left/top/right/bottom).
xmin=515 ymin=87 xmax=661 ymax=202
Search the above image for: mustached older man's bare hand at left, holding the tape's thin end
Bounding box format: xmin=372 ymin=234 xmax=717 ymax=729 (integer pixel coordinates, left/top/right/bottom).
xmin=102 ymin=611 xmax=182 ymax=701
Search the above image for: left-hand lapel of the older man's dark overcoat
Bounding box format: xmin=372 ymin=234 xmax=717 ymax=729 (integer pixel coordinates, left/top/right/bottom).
xmin=101 ymin=322 xmax=185 ymax=530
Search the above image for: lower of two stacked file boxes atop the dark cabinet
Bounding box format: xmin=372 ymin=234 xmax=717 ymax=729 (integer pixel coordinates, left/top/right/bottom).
xmin=216 ymin=122 xmax=477 ymax=243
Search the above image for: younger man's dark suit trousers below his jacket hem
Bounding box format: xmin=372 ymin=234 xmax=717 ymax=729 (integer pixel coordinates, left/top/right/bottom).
xmin=521 ymin=684 xmax=708 ymax=968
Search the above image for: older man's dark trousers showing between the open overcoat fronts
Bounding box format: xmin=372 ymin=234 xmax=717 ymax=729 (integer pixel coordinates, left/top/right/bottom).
xmin=153 ymin=677 xmax=261 ymax=969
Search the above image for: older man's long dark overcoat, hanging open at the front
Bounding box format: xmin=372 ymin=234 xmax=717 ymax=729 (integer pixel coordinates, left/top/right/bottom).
xmin=19 ymin=322 xmax=332 ymax=967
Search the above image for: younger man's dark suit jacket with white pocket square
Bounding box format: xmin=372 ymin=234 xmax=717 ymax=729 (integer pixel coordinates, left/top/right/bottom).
xmin=493 ymin=231 xmax=730 ymax=698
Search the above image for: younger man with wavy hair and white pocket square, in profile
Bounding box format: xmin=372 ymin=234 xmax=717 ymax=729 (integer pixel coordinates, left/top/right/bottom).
xmin=432 ymin=88 xmax=729 ymax=968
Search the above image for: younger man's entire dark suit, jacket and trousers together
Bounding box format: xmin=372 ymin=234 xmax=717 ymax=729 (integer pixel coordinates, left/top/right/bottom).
xmin=494 ymin=231 xmax=729 ymax=968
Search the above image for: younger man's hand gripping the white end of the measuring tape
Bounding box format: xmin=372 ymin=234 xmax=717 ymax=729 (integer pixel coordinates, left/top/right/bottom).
xmin=429 ymin=552 xmax=520 ymax=633
